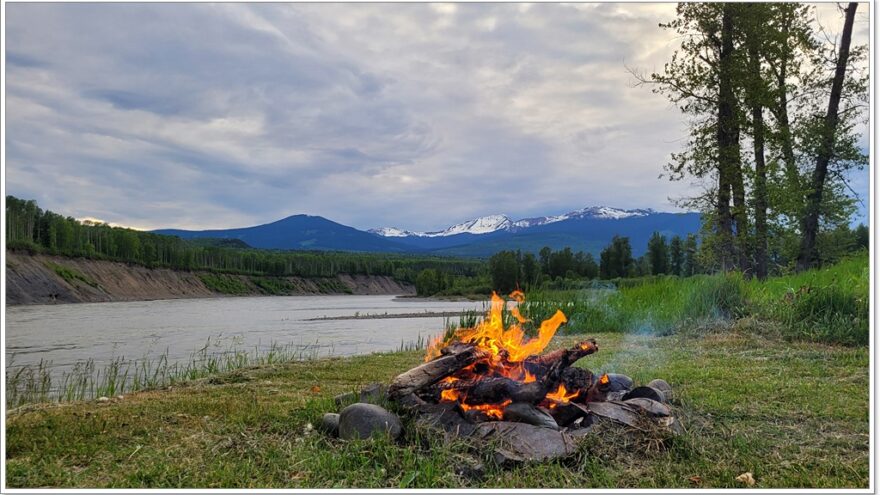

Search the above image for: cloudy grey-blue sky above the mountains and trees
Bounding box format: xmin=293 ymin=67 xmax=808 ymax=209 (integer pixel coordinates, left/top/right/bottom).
xmin=5 ymin=3 xmax=868 ymax=230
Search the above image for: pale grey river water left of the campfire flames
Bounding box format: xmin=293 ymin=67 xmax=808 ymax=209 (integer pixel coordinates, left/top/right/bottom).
xmin=6 ymin=295 xmax=484 ymax=386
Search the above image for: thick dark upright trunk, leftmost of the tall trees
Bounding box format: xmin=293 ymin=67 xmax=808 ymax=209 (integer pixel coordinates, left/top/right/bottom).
xmin=716 ymin=3 xmax=744 ymax=270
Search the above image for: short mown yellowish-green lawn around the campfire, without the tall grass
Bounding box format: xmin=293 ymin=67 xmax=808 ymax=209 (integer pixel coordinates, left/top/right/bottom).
xmin=6 ymin=330 xmax=869 ymax=488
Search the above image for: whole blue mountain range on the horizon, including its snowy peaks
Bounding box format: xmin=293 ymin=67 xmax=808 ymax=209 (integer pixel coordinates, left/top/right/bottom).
xmin=153 ymin=206 xmax=700 ymax=257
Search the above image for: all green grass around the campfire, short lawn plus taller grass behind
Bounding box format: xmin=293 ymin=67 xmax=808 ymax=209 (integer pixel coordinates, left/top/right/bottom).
xmin=6 ymin=255 xmax=870 ymax=488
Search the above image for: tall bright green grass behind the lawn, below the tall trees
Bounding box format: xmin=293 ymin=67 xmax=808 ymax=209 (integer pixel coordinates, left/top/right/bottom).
xmin=523 ymin=253 xmax=869 ymax=345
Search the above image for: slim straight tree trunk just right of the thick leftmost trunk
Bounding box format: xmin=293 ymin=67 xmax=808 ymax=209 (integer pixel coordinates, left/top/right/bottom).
xmin=749 ymin=40 xmax=768 ymax=280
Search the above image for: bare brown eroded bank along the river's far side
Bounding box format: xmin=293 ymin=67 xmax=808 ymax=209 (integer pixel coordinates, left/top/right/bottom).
xmin=6 ymin=251 xmax=415 ymax=305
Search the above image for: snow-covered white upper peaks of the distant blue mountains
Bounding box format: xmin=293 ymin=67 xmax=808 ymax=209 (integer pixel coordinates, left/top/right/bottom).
xmin=369 ymin=206 xmax=656 ymax=237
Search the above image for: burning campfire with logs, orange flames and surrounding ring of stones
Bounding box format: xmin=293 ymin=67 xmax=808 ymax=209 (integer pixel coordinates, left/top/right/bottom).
xmin=322 ymin=292 xmax=679 ymax=462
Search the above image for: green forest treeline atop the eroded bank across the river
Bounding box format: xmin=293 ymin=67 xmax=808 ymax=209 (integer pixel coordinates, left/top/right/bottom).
xmin=6 ymin=196 xmax=485 ymax=282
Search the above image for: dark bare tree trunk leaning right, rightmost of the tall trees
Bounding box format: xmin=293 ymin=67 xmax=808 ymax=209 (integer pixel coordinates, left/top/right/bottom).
xmin=797 ymin=2 xmax=859 ymax=270
